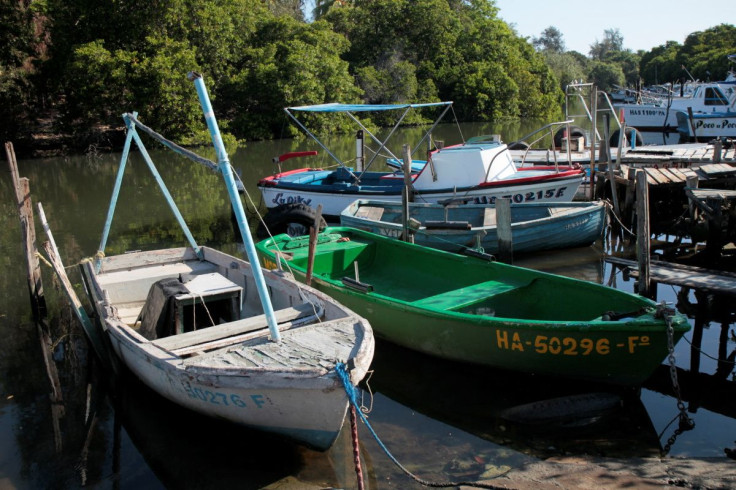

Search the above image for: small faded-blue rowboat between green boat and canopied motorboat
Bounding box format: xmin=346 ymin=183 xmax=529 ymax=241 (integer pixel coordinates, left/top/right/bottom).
xmin=340 ymin=199 xmax=606 ymax=254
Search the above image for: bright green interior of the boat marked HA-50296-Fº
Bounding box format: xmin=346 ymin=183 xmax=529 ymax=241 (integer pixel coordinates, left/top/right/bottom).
xmin=282 ymin=232 xmax=648 ymax=321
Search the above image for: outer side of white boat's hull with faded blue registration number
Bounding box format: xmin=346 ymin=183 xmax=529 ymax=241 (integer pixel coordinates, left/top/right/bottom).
xmin=108 ymin=323 xmax=354 ymax=450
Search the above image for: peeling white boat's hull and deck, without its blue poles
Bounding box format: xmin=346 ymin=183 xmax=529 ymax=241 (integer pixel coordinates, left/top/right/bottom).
xmin=83 ymin=247 xmax=374 ymax=450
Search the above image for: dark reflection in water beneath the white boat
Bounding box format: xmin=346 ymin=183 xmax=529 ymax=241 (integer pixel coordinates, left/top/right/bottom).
xmin=112 ymin=375 xmax=362 ymax=489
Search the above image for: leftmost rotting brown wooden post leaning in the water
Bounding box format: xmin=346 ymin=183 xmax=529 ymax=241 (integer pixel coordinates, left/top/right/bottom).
xmin=5 ymin=142 xmax=46 ymax=320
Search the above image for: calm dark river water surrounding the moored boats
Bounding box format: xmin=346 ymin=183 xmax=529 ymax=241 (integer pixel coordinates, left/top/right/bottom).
xmin=0 ymin=123 xmax=736 ymax=489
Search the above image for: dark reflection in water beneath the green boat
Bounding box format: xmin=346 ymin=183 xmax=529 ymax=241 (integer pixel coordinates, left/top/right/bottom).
xmin=370 ymin=341 xmax=661 ymax=457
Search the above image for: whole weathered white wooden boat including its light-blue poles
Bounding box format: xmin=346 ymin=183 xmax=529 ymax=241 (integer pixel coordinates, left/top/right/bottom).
xmin=82 ymin=74 xmax=374 ymax=449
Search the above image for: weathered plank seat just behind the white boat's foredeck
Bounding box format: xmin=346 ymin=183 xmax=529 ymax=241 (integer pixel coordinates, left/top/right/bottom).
xmin=152 ymin=303 xmax=320 ymax=354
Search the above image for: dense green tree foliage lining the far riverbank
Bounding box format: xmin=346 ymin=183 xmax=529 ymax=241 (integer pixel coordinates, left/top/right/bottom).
xmin=0 ymin=0 xmax=736 ymax=153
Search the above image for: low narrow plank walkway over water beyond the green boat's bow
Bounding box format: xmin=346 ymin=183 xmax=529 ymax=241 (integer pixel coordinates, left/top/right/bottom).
xmin=605 ymin=256 xmax=736 ymax=296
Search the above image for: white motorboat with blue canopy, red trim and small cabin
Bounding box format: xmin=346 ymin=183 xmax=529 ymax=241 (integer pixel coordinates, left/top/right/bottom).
xmin=258 ymin=102 xmax=583 ymax=217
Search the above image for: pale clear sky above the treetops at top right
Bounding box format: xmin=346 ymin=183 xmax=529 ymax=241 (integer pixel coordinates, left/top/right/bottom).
xmin=496 ymin=0 xmax=736 ymax=55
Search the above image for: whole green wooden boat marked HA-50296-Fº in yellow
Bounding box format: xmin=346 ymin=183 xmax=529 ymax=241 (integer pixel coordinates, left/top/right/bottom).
xmin=256 ymin=227 xmax=690 ymax=385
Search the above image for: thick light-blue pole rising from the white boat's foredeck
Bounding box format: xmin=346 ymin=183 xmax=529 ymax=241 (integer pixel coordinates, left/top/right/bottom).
xmin=187 ymin=72 xmax=281 ymax=342
